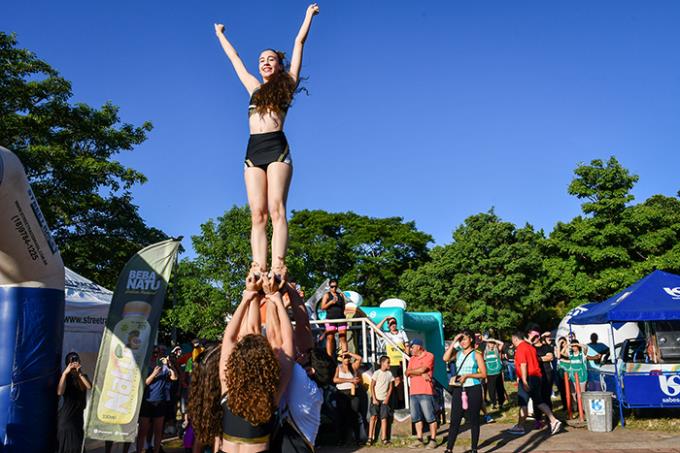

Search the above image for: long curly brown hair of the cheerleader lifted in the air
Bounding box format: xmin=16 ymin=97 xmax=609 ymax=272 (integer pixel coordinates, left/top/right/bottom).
xmin=253 ymin=49 xmax=297 ymax=116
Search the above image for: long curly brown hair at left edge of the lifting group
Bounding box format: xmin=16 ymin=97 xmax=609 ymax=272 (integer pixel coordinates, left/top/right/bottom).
xmin=188 ymin=345 xmax=222 ymax=445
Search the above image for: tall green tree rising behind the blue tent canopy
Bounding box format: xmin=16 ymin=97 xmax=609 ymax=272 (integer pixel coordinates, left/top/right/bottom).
xmin=542 ymin=157 xmax=680 ymax=313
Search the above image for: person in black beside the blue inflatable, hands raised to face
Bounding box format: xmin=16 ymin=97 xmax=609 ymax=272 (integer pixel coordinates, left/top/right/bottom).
xmin=57 ymin=352 xmax=92 ymax=453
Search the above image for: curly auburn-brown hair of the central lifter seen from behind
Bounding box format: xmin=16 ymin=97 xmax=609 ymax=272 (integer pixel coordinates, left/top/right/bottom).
xmin=225 ymin=334 xmax=280 ymax=425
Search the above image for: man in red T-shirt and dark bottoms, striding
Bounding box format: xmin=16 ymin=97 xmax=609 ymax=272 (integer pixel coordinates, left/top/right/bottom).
xmin=508 ymin=331 xmax=562 ymax=434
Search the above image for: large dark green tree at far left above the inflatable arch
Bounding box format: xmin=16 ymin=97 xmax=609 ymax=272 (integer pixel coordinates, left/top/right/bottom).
xmin=0 ymin=32 xmax=166 ymax=287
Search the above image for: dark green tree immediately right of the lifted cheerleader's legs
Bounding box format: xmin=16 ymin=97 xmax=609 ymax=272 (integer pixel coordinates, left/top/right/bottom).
xmin=289 ymin=210 xmax=432 ymax=305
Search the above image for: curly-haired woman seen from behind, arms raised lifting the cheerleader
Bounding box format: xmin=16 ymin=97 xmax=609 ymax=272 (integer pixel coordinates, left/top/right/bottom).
xmin=219 ymin=274 xmax=294 ymax=453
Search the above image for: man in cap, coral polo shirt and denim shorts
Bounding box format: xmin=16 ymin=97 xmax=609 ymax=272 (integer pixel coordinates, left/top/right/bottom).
xmin=406 ymin=338 xmax=438 ymax=449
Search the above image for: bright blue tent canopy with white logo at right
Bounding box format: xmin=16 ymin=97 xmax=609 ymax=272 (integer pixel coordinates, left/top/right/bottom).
xmin=569 ymin=271 xmax=680 ymax=324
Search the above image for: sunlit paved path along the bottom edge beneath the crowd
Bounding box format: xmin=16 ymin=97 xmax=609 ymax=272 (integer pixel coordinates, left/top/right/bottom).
xmin=87 ymin=423 xmax=680 ymax=453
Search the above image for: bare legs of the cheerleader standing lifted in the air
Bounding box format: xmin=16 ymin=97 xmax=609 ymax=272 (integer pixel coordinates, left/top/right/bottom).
xmin=244 ymin=162 xmax=293 ymax=270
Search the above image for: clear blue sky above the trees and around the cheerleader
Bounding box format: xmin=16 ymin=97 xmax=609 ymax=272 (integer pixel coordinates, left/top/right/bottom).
xmin=0 ymin=0 xmax=680 ymax=253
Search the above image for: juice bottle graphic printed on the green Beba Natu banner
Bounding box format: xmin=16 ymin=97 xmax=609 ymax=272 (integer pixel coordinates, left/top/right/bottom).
xmin=97 ymin=301 xmax=151 ymax=425
